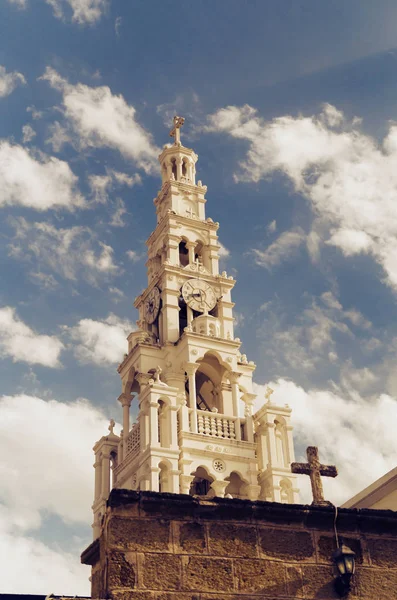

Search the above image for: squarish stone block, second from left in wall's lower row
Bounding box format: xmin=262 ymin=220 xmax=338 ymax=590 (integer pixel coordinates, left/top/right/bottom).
xmin=143 ymin=554 xmax=182 ymax=591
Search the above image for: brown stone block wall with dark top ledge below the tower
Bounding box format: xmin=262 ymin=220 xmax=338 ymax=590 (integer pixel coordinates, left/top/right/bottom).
xmin=82 ymin=490 xmax=397 ymax=600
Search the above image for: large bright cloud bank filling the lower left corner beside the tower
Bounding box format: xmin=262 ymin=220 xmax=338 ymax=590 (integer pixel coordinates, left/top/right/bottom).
xmin=0 ymin=394 xmax=111 ymax=595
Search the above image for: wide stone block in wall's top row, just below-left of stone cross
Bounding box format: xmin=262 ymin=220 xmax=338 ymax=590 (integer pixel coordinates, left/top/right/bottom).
xmin=259 ymin=528 xmax=314 ymax=562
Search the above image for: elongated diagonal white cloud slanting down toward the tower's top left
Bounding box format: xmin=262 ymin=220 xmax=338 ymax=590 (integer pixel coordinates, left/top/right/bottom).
xmin=41 ymin=67 xmax=160 ymax=173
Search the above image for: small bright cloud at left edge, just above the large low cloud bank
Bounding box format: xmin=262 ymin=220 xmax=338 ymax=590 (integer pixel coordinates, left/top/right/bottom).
xmin=0 ymin=306 xmax=64 ymax=368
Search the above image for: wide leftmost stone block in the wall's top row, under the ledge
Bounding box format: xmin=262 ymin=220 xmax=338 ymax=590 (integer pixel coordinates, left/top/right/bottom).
xmin=108 ymin=517 xmax=171 ymax=552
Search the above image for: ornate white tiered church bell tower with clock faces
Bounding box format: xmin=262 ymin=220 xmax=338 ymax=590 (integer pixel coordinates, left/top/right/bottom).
xmin=93 ymin=117 xmax=298 ymax=537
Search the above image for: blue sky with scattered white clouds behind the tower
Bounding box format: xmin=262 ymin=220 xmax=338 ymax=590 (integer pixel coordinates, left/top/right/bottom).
xmin=0 ymin=0 xmax=397 ymax=594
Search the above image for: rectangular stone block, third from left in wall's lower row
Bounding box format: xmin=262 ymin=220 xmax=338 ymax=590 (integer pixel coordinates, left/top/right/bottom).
xmin=183 ymin=556 xmax=233 ymax=594
